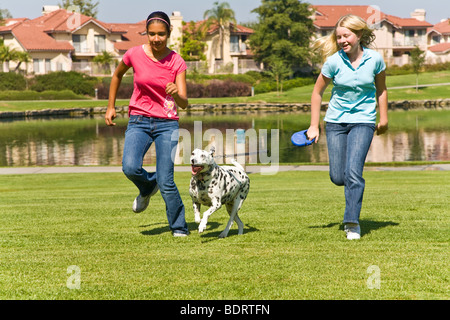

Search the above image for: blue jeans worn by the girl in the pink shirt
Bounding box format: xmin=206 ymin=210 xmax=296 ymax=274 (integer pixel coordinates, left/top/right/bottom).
xmin=122 ymin=115 xmax=188 ymax=233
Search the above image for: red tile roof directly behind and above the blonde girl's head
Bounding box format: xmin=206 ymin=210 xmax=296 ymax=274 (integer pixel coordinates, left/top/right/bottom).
xmin=312 ymin=5 xmax=432 ymax=28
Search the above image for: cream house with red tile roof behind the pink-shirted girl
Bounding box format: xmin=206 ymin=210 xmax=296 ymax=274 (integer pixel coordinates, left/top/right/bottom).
xmin=0 ymin=6 xmax=182 ymax=74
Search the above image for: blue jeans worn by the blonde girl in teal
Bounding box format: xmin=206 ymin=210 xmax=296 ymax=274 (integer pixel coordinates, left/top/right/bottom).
xmin=326 ymin=123 xmax=375 ymax=224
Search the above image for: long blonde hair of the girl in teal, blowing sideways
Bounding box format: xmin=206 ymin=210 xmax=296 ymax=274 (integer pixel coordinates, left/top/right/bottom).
xmin=313 ymin=14 xmax=375 ymax=60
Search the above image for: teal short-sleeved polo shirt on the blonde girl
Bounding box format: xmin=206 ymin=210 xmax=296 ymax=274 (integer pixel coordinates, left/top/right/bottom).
xmin=322 ymin=48 xmax=386 ymax=123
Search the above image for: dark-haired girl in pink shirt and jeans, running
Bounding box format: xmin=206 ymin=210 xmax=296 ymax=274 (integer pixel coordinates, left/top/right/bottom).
xmin=105 ymin=11 xmax=189 ymax=236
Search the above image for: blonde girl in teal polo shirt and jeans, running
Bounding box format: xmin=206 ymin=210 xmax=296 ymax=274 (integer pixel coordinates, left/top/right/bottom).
xmin=307 ymin=15 xmax=388 ymax=240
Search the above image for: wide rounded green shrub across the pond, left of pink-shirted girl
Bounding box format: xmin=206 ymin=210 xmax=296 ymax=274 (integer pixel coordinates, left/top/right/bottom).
xmin=30 ymin=71 xmax=98 ymax=96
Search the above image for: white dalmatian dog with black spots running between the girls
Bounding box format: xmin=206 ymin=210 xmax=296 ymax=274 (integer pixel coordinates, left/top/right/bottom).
xmin=189 ymin=148 xmax=250 ymax=238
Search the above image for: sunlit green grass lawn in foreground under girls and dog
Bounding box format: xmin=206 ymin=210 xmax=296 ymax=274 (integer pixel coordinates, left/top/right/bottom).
xmin=0 ymin=172 xmax=450 ymax=300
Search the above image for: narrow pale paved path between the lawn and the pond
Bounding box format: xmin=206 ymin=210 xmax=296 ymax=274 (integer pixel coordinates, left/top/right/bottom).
xmin=0 ymin=164 xmax=450 ymax=175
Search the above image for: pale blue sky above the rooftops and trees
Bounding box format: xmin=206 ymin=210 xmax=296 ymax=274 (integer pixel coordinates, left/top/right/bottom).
xmin=0 ymin=0 xmax=450 ymax=24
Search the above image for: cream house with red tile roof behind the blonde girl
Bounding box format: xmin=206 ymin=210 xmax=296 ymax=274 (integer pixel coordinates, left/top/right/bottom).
xmin=311 ymin=5 xmax=440 ymax=66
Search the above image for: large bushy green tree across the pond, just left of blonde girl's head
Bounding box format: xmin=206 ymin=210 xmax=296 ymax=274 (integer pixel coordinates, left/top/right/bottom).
xmin=250 ymin=0 xmax=314 ymax=69
